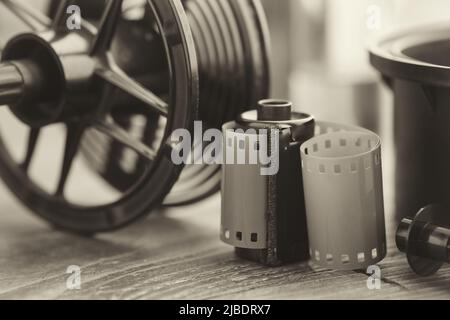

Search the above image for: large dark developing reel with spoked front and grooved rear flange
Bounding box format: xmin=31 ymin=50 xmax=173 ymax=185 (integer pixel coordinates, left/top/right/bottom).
xmin=0 ymin=0 xmax=269 ymax=234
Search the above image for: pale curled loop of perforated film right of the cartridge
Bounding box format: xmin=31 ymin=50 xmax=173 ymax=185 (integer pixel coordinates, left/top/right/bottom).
xmin=301 ymin=122 xmax=386 ymax=270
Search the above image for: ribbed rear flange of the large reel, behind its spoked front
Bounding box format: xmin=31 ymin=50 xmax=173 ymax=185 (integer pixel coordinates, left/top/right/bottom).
xmin=78 ymin=0 xmax=269 ymax=205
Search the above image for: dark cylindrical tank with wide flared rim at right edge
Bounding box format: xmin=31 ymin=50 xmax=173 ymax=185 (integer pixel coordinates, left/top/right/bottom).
xmin=370 ymin=24 xmax=450 ymax=219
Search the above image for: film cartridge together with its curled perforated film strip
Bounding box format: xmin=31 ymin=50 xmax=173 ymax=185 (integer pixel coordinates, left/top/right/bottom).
xmin=221 ymin=101 xmax=386 ymax=270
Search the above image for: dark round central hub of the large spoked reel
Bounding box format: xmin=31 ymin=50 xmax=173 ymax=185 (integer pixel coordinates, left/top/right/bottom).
xmin=0 ymin=32 xmax=118 ymax=127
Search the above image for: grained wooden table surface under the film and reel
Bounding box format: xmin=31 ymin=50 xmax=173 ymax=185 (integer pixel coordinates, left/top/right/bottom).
xmin=0 ymin=111 xmax=450 ymax=299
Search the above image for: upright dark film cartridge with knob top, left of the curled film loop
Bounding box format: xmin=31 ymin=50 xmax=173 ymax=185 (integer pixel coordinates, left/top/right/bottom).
xmin=221 ymin=100 xmax=314 ymax=266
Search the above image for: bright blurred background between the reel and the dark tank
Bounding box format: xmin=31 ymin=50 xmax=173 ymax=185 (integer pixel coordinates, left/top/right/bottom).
xmin=0 ymin=0 xmax=450 ymax=220
